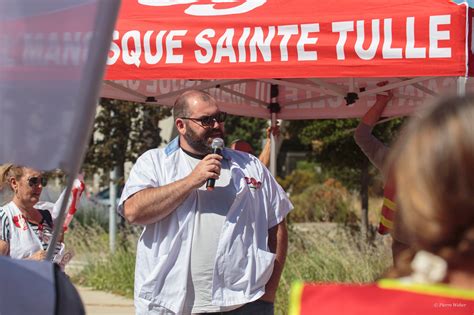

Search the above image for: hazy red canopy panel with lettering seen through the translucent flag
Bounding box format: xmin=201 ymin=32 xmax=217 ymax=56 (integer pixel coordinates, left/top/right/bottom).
xmin=0 ymin=3 xmax=96 ymax=82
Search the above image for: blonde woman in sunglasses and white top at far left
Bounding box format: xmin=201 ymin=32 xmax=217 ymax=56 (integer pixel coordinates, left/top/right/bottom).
xmin=0 ymin=164 xmax=57 ymax=260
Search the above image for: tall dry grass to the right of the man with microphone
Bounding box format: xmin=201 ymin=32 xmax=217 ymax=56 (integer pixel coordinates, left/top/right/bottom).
xmin=275 ymin=223 xmax=392 ymax=314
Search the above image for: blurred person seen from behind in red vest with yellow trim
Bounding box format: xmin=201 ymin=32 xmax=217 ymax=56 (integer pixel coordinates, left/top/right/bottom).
xmin=290 ymin=96 xmax=474 ymax=315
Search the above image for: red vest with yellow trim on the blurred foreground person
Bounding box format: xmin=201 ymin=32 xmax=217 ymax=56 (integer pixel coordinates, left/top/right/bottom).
xmin=289 ymin=279 xmax=474 ymax=315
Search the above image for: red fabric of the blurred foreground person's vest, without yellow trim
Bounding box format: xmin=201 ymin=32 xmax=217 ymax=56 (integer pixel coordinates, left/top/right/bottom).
xmin=300 ymin=284 xmax=474 ymax=315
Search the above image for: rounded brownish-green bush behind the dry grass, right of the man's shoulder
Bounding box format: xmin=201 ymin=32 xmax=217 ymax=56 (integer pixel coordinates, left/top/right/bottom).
xmin=290 ymin=179 xmax=357 ymax=225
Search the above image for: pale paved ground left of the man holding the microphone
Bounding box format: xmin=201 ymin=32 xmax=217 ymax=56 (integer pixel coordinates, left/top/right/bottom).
xmin=76 ymin=286 xmax=135 ymax=315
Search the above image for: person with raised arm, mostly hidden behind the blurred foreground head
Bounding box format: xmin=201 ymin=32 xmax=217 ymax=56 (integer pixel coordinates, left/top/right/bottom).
xmin=354 ymin=85 xmax=407 ymax=261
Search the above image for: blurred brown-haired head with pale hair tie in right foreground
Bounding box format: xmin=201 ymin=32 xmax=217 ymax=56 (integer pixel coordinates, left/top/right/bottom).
xmin=391 ymin=96 xmax=474 ymax=292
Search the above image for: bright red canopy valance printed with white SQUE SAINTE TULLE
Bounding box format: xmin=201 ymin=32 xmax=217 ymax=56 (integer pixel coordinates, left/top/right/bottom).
xmin=106 ymin=0 xmax=467 ymax=80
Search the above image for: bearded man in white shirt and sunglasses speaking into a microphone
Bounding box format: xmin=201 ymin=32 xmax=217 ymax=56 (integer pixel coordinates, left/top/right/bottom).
xmin=118 ymin=90 xmax=292 ymax=314
